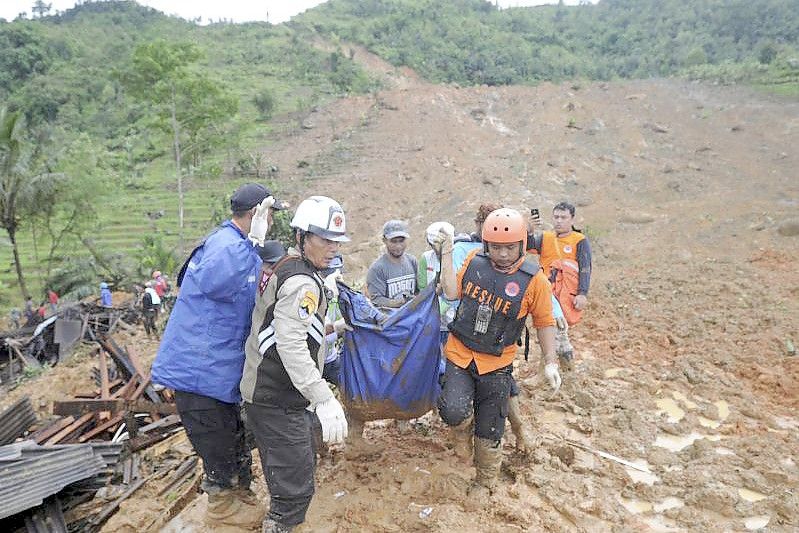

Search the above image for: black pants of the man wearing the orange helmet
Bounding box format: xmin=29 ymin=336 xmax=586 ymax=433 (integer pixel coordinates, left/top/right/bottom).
xmin=438 ymin=361 xmax=513 ymax=442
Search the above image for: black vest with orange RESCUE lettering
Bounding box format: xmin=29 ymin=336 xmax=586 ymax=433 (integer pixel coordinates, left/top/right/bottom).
xmin=449 ymin=253 xmax=540 ymax=356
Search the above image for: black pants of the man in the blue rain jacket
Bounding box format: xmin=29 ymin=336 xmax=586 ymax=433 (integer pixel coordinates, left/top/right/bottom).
xmin=175 ymin=391 xmax=252 ymax=492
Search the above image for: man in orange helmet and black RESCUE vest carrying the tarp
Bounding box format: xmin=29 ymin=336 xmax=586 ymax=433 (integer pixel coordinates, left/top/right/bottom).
xmin=435 ymin=208 xmax=561 ymax=496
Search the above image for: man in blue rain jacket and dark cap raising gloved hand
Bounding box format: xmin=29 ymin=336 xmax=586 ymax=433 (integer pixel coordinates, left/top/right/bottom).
xmin=152 ymin=183 xmax=283 ymax=531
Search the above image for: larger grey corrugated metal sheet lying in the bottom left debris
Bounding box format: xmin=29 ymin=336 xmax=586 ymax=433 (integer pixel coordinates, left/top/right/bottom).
xmin=0 ymin=444 xmax=106 ymax=519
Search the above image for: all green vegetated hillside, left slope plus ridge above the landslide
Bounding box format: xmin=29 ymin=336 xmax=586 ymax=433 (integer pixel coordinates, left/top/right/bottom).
xmin=0 ymin=0 xmax=799 ymax=307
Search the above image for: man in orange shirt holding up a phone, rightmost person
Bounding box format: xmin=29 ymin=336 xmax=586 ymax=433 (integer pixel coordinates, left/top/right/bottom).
xmin=529 ymin=202 xmax=591 ymax=369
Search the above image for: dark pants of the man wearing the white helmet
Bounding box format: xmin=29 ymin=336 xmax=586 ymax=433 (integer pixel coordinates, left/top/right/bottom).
xmin=244 ymin=402 xmax=316 ymax=526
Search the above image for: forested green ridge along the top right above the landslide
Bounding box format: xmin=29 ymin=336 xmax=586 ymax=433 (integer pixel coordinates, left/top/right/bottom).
xmin=291 ymin=0 xmax=799 ymax=88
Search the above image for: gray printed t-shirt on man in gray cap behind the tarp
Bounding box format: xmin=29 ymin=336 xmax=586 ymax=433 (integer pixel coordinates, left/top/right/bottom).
xmin=366 ymin=253 xmax=418 ymax=307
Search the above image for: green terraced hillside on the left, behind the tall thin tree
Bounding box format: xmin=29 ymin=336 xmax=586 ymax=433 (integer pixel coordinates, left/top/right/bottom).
xmin=0 ymin=1 xmax=374 ymax=306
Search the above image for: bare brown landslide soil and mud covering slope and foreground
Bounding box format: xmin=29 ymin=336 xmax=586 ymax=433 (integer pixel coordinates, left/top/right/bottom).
xmin=3 ymin=45 xmax=799 ymax=532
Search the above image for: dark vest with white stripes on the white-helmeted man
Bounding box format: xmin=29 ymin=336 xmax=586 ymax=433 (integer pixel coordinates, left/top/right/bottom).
xmin=253 ymin=256 xmax=327 ymax=408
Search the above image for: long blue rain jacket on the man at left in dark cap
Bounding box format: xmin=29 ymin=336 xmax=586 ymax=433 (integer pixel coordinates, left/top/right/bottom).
xmin=152 ymin=220 xmax=261 ymax=403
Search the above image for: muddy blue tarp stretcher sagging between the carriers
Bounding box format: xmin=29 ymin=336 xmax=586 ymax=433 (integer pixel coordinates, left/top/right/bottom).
xmin=338 ymin=285 xmax=441 ymax=420
